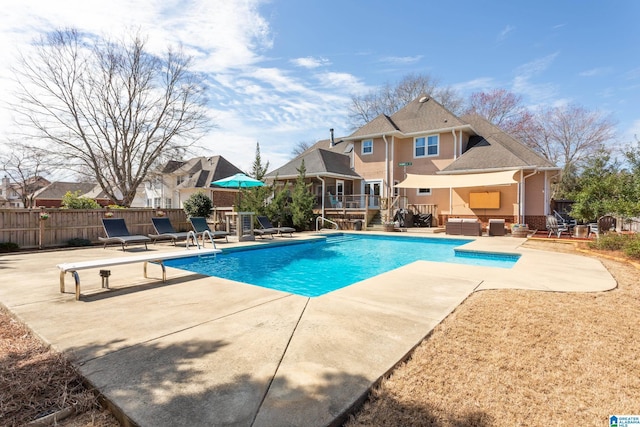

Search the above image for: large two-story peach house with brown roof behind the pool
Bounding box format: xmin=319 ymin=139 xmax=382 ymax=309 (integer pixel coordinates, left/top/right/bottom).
xmin=267 ymin=96 xmax=561 ymax=228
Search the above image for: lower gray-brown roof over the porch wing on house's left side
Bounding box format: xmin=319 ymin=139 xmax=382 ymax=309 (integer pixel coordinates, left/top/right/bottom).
xmin=265 ymin=149 xmax=361 ymax=179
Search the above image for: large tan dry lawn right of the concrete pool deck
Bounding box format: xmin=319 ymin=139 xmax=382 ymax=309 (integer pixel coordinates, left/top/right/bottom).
xmin=347 ymin=242 xmax=640 ymax=427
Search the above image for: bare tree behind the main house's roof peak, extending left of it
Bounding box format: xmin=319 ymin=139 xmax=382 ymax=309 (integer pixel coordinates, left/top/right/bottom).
xmin=349 ymin=74 xmax=462 ymax=129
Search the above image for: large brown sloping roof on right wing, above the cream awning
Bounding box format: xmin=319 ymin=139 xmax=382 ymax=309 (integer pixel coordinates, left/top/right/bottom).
xmin=440 ymin=115 xmax=559 ymax=173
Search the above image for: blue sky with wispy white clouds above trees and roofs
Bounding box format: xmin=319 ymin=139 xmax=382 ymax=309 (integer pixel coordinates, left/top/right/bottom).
xmin=0 ymin=0 xmax=640 ymax=177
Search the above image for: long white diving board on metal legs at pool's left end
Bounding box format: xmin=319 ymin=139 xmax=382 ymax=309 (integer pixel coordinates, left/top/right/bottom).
xmin=56 ymin=248 xmax=222 ymax=301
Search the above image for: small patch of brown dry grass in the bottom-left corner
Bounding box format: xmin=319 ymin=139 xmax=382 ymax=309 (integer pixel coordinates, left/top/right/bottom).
xmin=0 ymin=306 xmax=119 ymax=427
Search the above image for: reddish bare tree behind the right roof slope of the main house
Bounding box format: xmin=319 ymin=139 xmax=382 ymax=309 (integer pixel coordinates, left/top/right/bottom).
xmin=465 ymin=89 xmax=535 ymax=139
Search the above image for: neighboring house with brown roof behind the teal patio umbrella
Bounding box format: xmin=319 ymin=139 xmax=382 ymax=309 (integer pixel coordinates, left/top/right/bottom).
xmin=144 ymin=156 xmax=242 ymax=209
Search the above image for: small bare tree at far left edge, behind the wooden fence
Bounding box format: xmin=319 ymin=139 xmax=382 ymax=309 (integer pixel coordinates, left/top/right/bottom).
xmin=0 ymin=144 xmax=49 ymax=208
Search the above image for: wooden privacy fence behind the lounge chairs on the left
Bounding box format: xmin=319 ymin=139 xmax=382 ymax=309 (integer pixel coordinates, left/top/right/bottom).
xmin=0 ymin=208 xmax=191 ymax=249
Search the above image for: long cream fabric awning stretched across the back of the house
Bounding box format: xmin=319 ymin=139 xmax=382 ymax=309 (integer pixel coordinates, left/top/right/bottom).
xmin=396 ymin=170 xmax=519 ymax=188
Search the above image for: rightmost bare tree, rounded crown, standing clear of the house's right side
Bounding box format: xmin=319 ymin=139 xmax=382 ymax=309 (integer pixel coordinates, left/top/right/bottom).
xmin=523 ymin=104 xmax=615 ymax=170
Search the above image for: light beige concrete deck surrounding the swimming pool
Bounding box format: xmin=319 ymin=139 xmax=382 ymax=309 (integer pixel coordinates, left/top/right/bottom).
xmin=0 ymin=233 xmax=616 ymax=426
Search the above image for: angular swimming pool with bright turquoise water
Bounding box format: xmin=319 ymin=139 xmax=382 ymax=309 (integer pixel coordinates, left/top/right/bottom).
xmin=165 ymin=234 xmax=519 ymax=297
